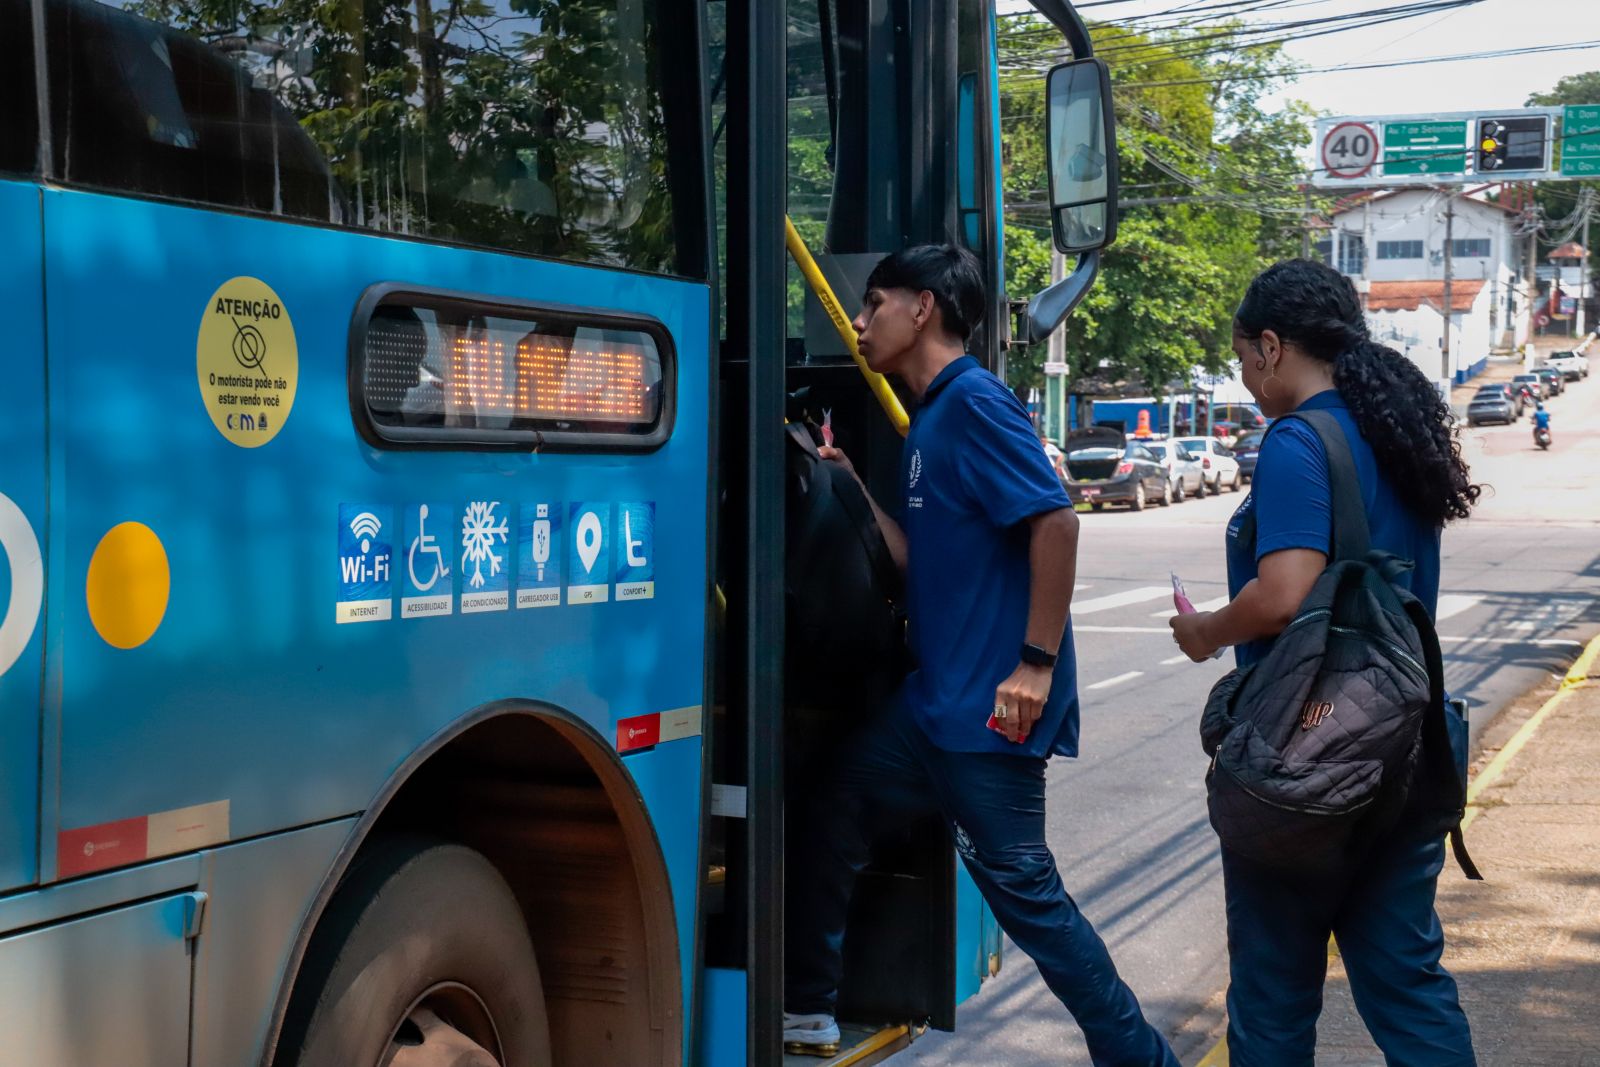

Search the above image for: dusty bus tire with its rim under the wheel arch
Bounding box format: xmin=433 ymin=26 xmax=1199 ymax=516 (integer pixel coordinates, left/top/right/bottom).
xmin=274 ymin=837 xmax=550 ymax=1067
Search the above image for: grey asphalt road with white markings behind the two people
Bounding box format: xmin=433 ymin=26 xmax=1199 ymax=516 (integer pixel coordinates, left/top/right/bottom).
xmin=896 ymin=360 xmax=1600 ymax=1067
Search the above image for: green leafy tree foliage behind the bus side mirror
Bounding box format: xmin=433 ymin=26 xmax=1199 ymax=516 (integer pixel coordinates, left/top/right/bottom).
xmin=1000 ymin=16 xmax=1322 ymax=392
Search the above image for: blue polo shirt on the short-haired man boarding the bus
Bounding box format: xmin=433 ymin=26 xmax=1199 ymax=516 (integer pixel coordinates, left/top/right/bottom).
xmin=901 ymin=355 xmax=1078 ymax=757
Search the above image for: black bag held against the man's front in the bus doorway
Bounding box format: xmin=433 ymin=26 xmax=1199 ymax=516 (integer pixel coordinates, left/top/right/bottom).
xmin=784 ymin=422 xmax=907 ymax=765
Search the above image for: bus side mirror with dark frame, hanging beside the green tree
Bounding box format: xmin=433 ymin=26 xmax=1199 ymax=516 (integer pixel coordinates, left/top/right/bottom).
xmin=1045 ymin=58 xmax=1117 ymax=256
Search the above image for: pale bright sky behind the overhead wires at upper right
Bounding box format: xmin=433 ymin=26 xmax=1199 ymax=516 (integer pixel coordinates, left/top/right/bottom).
xmin=1000 ymin=0 xmax=1600 ymax=117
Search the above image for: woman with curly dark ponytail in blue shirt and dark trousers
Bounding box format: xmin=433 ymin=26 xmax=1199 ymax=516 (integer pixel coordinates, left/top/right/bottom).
xmin=1171 ymin=259 xmax=1480 ymax=1067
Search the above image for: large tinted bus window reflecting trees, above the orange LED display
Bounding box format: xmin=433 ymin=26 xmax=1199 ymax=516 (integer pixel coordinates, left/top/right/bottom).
xmin=43 ymin=0 xmax=677 ymax=270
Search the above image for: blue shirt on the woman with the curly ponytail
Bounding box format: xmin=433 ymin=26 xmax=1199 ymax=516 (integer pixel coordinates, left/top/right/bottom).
xmin=1227 ymin=389 xmax=1440 ymax=667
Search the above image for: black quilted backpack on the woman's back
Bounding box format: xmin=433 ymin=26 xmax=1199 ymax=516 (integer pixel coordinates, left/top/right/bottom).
xmin=1200 ymin=411 xmax=1478 ymax=878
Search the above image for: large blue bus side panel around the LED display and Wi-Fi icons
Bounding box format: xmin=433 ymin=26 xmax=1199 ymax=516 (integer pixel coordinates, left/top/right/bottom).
xmin=45 ymin=190 xmax=710 ymax=927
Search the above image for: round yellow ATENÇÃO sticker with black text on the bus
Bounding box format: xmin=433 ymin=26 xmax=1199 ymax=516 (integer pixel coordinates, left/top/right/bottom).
xmin=195 ymin=277 xmax=299 ymax=448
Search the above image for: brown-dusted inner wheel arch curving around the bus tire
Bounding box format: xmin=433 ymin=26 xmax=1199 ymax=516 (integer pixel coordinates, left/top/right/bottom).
xmin=261 ymin=701 xmax=686 ymax=1067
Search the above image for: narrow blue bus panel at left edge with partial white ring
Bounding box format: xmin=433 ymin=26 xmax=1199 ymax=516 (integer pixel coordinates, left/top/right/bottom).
xmin=0 ymin=182 xmax=45 ymax=893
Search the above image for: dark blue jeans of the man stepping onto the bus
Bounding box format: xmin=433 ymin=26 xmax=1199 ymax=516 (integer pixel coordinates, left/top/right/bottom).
xmin=784 ymin=701 xmax=1178 ymax=1067
